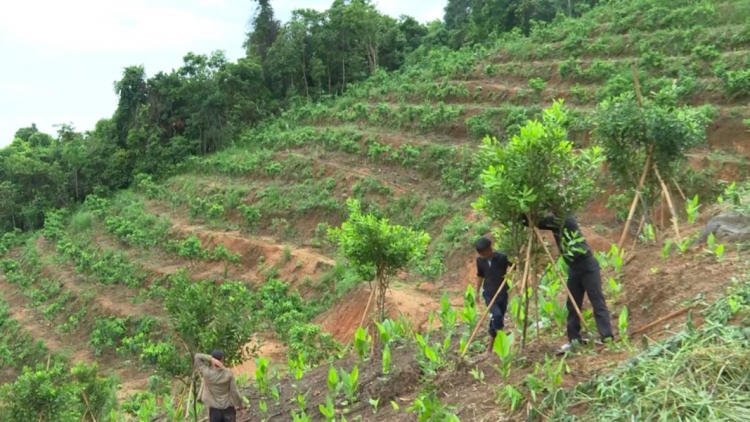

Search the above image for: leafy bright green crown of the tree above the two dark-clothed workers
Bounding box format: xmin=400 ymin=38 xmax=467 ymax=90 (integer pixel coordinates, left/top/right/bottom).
xmin=473 ymin=101 xmax=604 ymax=251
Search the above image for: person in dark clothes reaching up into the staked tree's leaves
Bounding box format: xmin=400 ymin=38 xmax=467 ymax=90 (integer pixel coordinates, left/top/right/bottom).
xmin=521 ymin=212 xmax=613 ymax=352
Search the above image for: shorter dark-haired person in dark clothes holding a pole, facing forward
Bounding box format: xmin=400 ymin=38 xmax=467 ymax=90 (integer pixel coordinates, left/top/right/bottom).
xmin=476 ymin=237 xmax=511 ymax=353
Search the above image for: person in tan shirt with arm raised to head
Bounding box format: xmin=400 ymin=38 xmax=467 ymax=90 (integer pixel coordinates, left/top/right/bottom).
xmin=194 ymin=350 xmax=245 ymax=422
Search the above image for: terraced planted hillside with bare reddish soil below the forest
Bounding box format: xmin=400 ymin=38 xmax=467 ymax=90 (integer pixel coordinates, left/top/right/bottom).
xmin=0 ymin=0 xmax=750 ymax=421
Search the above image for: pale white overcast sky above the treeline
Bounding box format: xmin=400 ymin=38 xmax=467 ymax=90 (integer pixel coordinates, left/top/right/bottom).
xmin=0 ymin=0 xmax=445 ymax=147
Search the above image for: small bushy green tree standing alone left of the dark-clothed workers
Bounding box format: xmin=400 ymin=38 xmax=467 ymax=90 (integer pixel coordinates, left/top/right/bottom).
xmin=328 ymin=198 xmax=430 ymax=321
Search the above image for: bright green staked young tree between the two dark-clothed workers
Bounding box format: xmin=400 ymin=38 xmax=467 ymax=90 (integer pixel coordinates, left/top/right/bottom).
xmin=474 ymin=101 xmax=604 ymax=347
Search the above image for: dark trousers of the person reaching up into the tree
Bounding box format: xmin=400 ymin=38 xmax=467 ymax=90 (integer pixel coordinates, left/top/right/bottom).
xmin=567 ymin=256 xmax=612 ymax=341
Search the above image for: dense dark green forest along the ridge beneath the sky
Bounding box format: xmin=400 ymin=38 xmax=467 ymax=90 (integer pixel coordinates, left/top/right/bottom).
xmin=0 ymin=0 xmax=604 ymax=231
